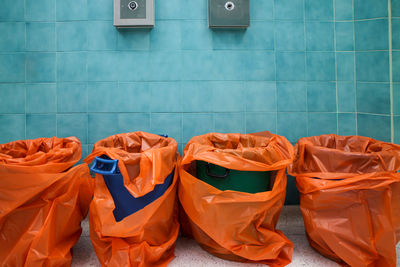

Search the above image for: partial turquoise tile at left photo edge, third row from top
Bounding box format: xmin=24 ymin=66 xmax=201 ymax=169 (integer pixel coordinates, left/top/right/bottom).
xmin=0 ymin=53 xmax=25 ymax=82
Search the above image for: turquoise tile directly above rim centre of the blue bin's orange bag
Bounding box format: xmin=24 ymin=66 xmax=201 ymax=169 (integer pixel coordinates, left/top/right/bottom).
xmin=118 ymin=113 xmax=150 ymax=133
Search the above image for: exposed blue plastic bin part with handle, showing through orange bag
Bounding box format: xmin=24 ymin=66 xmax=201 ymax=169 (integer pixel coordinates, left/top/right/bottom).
xmin=90 ymin=156 xmax=175 ymax=222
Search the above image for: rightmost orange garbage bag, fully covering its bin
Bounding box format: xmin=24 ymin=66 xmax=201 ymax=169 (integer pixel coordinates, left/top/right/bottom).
xmin=289 ymin=134 xmax=400 ymax=267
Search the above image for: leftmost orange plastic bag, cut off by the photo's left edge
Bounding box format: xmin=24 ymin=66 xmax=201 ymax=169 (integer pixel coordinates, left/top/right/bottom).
xmin=0 ymin=137 xmax=93 ymax=266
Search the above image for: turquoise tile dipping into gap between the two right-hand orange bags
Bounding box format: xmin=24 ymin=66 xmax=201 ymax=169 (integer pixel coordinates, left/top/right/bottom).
xmin=277 ymin=112 xmax=308 ymax=142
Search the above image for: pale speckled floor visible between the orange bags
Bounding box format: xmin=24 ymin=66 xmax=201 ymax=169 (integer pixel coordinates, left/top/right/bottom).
xmin=72 ymin=206 xmax=400 ymax=267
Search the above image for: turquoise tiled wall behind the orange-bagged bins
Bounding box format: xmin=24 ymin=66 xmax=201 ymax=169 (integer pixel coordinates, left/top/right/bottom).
xmin=0 ymin=0 xmax=394 ymax=205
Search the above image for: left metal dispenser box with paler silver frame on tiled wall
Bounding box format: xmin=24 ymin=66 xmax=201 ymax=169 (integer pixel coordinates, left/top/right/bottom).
xmin=114 ymin=0 xmax=154 ymax=28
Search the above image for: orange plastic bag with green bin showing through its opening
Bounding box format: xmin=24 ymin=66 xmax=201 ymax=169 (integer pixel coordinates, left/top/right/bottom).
xmin=179 ymin=132 xmax=293 ymax=266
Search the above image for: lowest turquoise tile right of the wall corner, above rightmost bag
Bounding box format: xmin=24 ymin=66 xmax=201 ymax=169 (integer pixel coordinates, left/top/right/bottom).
xmin=357 ymin=114 xmax=391 ymax=142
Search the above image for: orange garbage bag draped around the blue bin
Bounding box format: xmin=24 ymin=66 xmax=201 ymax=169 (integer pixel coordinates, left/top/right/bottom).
xmin=85 ymin=132 xmax=180 ymax=267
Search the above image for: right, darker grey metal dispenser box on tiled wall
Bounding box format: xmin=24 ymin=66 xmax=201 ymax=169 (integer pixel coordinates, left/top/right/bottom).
xmin=208 ymin=0 xmax=250 ymax=28
